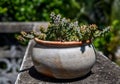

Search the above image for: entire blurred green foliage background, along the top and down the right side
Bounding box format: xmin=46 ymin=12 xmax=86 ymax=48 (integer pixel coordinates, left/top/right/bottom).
xmin=0 ymin=0 xmax=120 ymax=65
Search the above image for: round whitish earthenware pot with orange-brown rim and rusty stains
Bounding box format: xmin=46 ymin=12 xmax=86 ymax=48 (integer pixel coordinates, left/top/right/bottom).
xmin=32 ymin=38 xmax=96 ymax=79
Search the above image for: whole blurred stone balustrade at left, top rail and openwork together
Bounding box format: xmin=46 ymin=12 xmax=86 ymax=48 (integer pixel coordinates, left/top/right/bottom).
xmin=0 ymin=22 xmax=48 ymax=84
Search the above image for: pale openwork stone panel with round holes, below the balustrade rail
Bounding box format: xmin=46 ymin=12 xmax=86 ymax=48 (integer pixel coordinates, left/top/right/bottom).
xmin=0 ymin=45 xmax=25 ymax=84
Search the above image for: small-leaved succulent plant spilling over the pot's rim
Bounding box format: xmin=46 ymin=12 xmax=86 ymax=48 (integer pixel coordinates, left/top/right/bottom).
xmin=18 ymin=13 xmax=110 ymax=41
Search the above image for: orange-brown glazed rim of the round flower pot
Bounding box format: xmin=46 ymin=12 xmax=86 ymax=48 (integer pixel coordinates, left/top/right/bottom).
xmin=34 ymin=38 xmax=91 ymax=47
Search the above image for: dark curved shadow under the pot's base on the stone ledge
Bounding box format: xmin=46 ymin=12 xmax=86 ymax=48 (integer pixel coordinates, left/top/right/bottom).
xmin=29 ymin=66 xmax=93 ymax=83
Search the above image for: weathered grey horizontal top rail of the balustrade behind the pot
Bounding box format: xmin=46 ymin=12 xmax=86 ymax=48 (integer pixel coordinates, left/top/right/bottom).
xmin=0 ymin=22 xmax=46 ymax=33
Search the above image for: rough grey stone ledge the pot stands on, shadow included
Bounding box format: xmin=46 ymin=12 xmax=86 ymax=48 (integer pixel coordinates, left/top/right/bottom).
xmin=15 ymin=41 xmax=120 ymax=84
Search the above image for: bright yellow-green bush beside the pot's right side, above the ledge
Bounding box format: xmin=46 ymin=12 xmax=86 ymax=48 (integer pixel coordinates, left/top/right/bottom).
xmin=94 ymin=20 xmax=120 ymax=60
